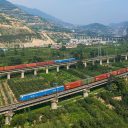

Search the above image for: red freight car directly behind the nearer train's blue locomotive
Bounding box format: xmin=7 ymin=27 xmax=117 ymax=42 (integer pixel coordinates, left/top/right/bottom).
xmin=64 ymin=80 xmax=82 ymax=90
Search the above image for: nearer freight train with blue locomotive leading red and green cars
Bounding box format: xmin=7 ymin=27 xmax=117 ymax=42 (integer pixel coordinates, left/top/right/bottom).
xmin=19 ymin=68 xmax=128 ymax=102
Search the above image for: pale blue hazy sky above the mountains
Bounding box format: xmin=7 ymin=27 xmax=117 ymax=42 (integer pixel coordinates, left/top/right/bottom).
xmin=9 ymin=0 xmax=128 ymax=24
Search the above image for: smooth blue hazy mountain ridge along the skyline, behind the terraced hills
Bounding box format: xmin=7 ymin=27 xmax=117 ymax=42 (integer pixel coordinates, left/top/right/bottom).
xmin=17 ymin=5 xmax=128 ymax=36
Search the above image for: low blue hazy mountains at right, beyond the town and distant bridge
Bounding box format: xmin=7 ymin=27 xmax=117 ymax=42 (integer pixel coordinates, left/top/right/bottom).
xmin=77 ymin=22 xmax=128 ymax=37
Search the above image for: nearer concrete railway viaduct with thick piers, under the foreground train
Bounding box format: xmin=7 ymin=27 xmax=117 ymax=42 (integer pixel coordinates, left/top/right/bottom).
xmin=0 ymin=72 xmax=128 ymax=125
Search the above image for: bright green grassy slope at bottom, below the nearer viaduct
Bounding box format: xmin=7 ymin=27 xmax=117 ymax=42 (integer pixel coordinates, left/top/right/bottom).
xmin=13 ymin=97 xmax=128 ymax=128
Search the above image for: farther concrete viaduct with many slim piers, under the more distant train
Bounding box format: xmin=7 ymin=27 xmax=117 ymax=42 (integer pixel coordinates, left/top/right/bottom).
xmin=0 ymin=53 xmax=128 ymax=79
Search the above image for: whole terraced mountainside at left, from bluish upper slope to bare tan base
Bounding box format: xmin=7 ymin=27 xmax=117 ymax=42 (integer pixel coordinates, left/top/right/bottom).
xmin=0 ymin=0 xmax=63 ymax=47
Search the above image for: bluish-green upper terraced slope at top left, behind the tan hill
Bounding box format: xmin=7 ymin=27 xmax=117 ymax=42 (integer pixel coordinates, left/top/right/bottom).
xmin=0 ymin=0 xmax=52 ymax=28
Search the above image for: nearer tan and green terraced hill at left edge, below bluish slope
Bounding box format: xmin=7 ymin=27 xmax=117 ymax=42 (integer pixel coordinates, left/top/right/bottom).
xmin=0 ymin=13 xmax=39 ymax=45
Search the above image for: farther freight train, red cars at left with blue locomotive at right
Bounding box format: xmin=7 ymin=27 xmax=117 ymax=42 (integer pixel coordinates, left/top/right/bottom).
xmin=0 ymin=58 xmax=77 ymax=71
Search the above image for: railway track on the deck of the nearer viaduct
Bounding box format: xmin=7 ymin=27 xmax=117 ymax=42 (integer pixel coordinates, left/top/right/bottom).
xmin=0 ymin=72 xmax=128 ymax=115
